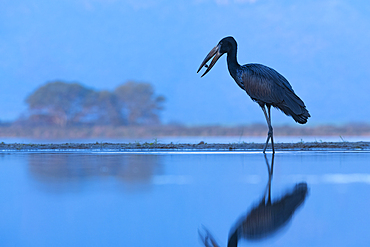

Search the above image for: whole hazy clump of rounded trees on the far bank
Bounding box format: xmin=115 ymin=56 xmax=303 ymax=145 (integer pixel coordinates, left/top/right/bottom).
xmin=25 ymin=81 xmax=165 ymax=126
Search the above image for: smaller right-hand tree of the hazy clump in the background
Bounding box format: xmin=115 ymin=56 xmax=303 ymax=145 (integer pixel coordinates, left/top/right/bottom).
xmin=114 ymin=81 xmax=165 ymax=125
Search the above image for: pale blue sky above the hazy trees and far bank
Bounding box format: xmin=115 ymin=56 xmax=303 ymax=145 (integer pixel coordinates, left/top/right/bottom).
xmin=0 ymin=0 xmax=370 ymax=126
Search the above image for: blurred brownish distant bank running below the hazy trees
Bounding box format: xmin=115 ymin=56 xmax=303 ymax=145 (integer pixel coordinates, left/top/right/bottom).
xmin=0 ymin=124 xmax=370 ymax=141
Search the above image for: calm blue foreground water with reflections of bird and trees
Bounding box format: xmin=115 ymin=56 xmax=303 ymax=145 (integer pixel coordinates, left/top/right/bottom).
xmin=0 ymin=152 xmax=370 ymax=247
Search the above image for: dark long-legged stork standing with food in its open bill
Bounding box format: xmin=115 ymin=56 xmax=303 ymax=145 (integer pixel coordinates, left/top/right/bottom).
xmin=197 ymin=36 xmax=311 ymax=153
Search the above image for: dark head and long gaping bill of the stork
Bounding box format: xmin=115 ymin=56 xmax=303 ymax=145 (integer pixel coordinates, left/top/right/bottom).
xmin=197 ymin=36 xmax=236 ymax=77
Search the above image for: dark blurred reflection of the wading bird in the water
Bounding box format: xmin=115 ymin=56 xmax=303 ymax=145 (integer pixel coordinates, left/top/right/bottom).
xmin=199 ymin=155 xmax=307 ymax=247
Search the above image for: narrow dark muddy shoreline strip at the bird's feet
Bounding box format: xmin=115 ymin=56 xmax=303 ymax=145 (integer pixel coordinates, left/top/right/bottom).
xmin=0 ymin=142 xmax=370 ymax=153
